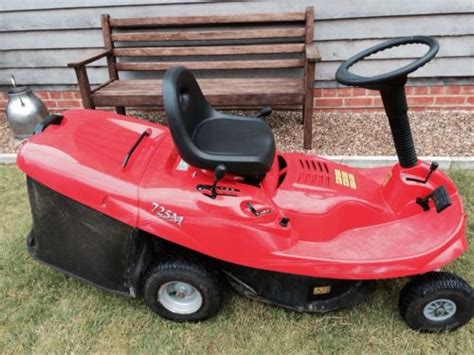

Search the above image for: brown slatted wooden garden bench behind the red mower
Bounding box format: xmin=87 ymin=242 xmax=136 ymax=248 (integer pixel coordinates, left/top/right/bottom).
xmin=68 ymin=7 xmax=319 ymax=148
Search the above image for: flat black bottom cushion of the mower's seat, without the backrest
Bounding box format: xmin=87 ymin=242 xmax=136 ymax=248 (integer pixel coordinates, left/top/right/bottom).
xmin=192 ymin=115 xmax=275 ymax=176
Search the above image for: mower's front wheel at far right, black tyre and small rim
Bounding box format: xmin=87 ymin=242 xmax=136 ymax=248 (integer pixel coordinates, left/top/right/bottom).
xmin=399 ymin=272 xmax=474 ymax=333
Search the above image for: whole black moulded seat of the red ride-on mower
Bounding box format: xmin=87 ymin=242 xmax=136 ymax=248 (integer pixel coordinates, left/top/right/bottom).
xmin=163 ymin=67 xmax=275 ymax=178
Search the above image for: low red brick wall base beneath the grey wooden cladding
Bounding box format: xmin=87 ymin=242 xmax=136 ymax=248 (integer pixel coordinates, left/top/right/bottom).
xmin=0 ymin=85 xmax=474 ymax=112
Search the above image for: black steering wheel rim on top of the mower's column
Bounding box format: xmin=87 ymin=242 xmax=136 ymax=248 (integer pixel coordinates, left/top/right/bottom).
xmin=336 ymin=36 xmax=439 ymax=90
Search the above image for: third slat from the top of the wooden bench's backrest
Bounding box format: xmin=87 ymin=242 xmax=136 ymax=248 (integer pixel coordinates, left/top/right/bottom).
xmin=113 ymin=43 xmax=305 ymax=57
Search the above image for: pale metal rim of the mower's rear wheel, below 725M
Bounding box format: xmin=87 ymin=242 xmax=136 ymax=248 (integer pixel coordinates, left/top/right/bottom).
xmin=158 ymin=281 xmax=202 ymax=314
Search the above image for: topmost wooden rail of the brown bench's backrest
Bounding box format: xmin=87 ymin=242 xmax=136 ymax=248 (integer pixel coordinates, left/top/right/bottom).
xmin=110 ymin=12 xmax=305 ymax=28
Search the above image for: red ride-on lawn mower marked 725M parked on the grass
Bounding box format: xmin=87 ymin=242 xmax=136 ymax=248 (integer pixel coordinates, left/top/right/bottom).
xmin=17 ymin=36 xmax=474 ymax=332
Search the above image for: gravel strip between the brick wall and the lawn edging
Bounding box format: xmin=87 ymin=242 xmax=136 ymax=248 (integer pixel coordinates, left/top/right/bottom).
xmin=0 ymin=111 xmax=474 ymax=156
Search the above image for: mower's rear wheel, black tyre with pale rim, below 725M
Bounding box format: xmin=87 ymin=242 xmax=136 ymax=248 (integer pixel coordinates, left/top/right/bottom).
xmin=143 ymin=259 xmax=222 ymax=322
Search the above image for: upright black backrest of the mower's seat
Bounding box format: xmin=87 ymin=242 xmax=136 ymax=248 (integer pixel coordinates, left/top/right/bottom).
xmin=163 ymin=67 xmax=215 ymax=162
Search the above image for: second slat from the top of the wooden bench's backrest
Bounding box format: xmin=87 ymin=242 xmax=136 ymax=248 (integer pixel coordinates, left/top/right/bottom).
xmin=112 ymin=27 xmax=305 ymax=42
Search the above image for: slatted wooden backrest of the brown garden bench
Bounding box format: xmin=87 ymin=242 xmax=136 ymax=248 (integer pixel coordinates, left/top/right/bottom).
xmin=98 ymin=7 xmax=314 ymax=81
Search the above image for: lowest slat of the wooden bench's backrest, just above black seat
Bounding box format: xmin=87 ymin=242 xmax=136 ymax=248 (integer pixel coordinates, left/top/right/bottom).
xmin=115 ymin=59 xmax=304 ymax=71
